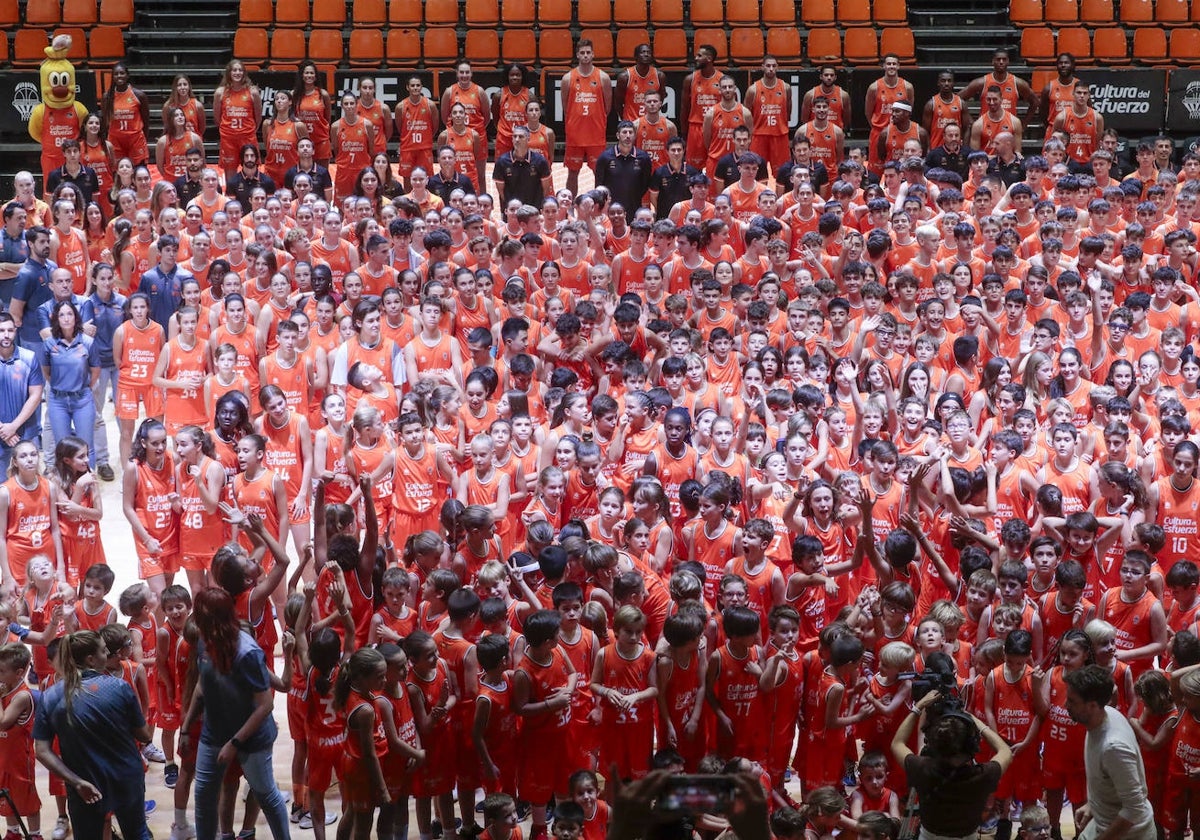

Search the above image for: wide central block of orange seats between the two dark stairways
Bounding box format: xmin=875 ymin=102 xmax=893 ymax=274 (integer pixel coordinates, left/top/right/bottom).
xmin=231 ymin=0 xmax=914 ymax=70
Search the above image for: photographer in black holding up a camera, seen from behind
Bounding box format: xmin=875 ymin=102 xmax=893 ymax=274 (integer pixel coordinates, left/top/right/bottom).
xmin=892 ymin=654 xmax=1013 ymax=840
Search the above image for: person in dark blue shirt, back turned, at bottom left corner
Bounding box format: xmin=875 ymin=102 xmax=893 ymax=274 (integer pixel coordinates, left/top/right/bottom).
xmin=34 ymin=630 xmax=154 ymax=840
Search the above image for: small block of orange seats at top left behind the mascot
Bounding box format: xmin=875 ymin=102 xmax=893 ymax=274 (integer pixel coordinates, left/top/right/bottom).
xmin=0 ymin=0 xmax=126 ymax=68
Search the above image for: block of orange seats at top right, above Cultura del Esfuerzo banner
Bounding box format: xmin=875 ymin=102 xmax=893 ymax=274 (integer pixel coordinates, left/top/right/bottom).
xmin=1008 ymin=0 xmax=1200 ymax=66
